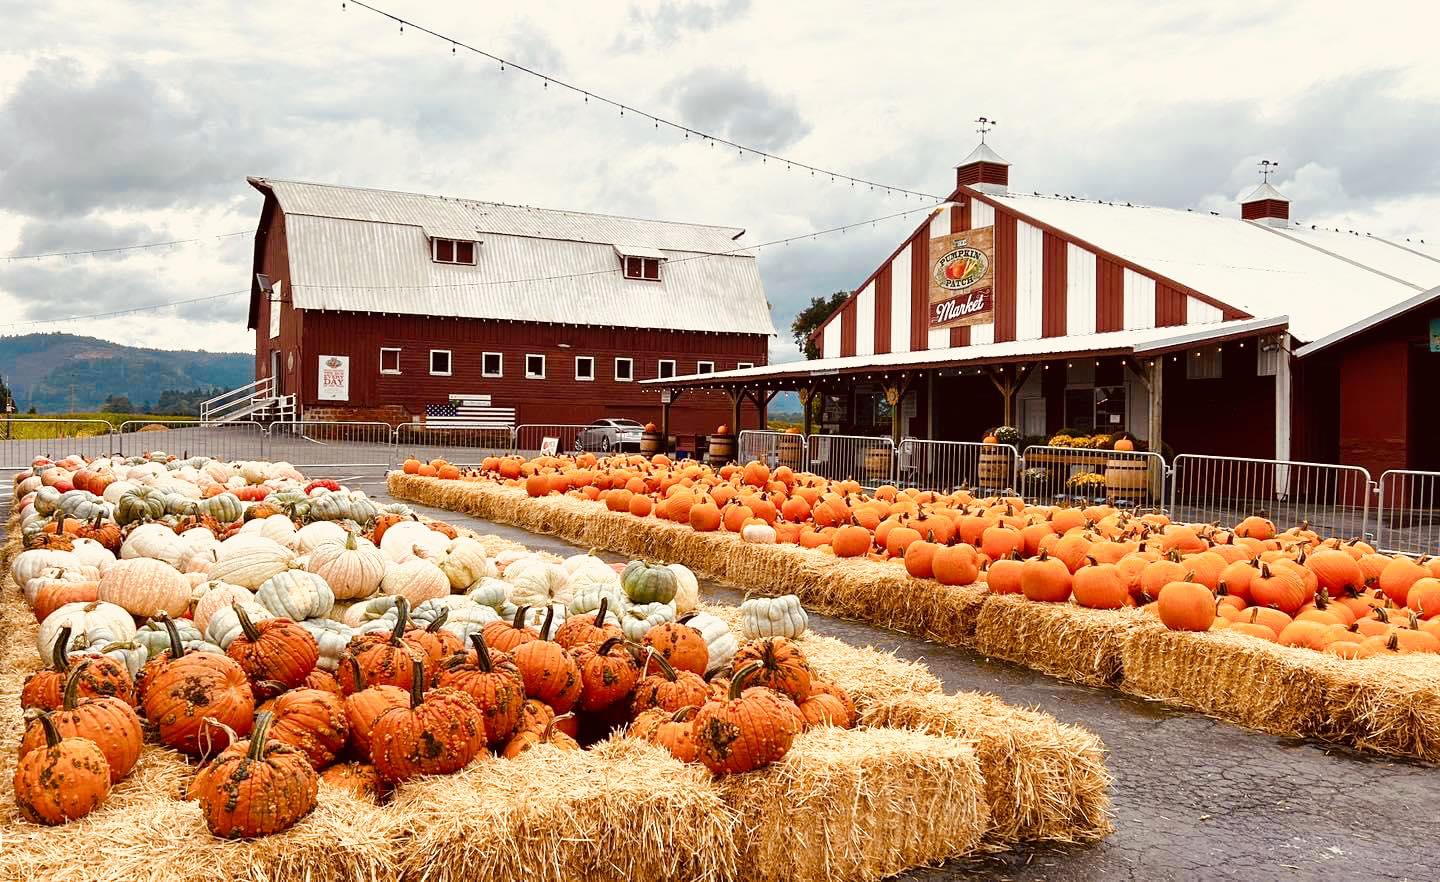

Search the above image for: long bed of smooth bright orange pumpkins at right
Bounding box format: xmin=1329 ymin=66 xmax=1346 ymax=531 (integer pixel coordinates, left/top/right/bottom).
xmin=423 ymin=454 xmax=1440 ymax=659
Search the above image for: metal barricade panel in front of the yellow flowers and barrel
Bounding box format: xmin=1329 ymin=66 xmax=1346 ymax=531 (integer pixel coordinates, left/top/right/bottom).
xmin=1015 ymin=447 xmax=1165 ymax=509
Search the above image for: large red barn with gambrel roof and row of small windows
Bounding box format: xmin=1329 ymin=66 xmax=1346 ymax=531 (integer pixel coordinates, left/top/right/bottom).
xmin=249 ymin=177 xmax=775 ymax=434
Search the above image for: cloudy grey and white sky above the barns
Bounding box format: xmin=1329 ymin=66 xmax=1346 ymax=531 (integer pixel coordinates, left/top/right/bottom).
xmin=0 ymin=0 xmax=1440 ymax=359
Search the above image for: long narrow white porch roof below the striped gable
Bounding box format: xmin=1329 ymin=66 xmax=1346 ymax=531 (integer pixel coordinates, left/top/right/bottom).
xmin=641 ymin=316 xmax=1289 ymax=388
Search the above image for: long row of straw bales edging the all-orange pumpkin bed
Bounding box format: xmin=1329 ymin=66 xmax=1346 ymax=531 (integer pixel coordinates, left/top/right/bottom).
xmin=390 ymin=474 xmax=1440 ymax=762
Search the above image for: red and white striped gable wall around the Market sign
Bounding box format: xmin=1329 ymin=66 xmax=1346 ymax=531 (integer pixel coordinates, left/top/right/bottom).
xmin=815 ymin=191 xmax=1251 ymax=359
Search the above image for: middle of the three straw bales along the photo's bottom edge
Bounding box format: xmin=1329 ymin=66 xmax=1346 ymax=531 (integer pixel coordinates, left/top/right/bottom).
xmin=390 ymin=739 xmax=737 ymax=882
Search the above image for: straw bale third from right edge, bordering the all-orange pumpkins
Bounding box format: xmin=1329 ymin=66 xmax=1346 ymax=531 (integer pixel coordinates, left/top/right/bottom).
xmin=975 ymin=595 xmax=1165 ymax=686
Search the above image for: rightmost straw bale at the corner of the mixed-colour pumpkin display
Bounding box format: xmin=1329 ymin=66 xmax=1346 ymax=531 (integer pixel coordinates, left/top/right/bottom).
xmin=861 ymin=692 xmax=1113 ymax=843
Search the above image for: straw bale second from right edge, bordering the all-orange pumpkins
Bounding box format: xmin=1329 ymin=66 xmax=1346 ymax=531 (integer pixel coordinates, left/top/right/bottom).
xmin=1119 ymin=625 xmax=1324 ymax=735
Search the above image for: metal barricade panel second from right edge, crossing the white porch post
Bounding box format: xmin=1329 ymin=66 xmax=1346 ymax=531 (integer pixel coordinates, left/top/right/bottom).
xmin=1171 ymin=454 xmax=1371 ymax=538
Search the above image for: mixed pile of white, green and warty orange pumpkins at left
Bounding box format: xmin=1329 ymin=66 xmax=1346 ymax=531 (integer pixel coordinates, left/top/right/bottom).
xmin=12 ymin=453 xmax=854 ymax=837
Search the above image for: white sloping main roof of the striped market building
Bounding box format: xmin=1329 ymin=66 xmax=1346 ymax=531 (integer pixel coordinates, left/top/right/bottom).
xmin=991 ymin=195 xmax=1440 ymax=343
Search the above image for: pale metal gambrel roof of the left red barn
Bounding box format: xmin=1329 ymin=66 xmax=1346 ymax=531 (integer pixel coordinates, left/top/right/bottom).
xmin=249 ymin=177 xmax=775 ymax=334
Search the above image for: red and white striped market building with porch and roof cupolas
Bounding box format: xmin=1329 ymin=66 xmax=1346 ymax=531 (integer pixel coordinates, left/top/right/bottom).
xmin=648 ymin=141 xmax=1440 ymax=474
